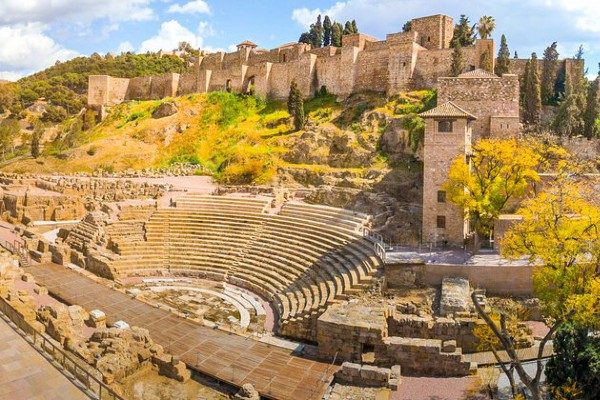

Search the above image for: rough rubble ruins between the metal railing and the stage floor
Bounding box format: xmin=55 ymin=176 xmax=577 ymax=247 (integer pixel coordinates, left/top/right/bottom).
xmin=0 ymin=255 xmax=191 ymax=384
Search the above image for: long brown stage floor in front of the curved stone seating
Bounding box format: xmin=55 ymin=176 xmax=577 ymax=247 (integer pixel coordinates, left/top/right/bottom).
xmin=27 ymin=264 xmax=338 ymax=400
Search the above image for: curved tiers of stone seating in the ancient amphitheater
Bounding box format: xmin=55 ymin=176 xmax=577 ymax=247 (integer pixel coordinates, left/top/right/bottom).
xmin=113 ymin=195 xmax=382 ymax=339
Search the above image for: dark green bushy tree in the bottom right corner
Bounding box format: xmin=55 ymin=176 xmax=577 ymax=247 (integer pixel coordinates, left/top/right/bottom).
xmin=546 ymin=322 xmax=600 ymax=400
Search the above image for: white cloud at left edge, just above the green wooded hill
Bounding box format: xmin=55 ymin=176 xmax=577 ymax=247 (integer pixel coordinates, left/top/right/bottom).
xmin=0 ymin=23 xmax=78 ymax=79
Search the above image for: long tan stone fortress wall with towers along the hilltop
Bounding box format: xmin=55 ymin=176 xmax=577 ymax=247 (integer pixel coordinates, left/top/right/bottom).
xmin=88 ymin=15 xmax=573 ymax=107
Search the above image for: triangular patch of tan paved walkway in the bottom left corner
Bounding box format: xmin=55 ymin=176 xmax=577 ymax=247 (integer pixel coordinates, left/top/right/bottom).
xmin=0 ymin=318 xmax=89 ymax=400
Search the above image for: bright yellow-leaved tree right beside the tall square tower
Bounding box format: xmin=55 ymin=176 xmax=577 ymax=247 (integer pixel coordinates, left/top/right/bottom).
xmin=444 ymin=139 xmax=542 ymax=241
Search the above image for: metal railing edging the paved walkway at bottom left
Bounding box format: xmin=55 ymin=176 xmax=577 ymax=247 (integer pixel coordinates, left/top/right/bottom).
xmin=0 ymin=298 xmax=125 ymax=400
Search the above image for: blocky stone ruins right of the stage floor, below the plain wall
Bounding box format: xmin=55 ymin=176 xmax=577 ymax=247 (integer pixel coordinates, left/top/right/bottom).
xmin=317 ymin=278 xmax=534 ymax=376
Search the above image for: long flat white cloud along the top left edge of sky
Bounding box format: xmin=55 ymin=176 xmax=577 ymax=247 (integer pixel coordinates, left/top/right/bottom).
xmin=0 ymin=0 xmax=155 ymax=24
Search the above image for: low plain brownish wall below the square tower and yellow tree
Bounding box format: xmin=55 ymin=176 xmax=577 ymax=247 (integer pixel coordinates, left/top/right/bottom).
xmin=385 ymin=264 xmax=535 ymax=296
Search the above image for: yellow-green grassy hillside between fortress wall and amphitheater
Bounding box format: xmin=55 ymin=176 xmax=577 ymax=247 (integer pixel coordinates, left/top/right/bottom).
xmin=3 ymin=91 xmax=435 ymax=184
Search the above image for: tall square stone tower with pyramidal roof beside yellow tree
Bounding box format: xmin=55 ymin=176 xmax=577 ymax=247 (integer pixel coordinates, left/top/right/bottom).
xmin=421 ymin=102 xmax=477 ymax=247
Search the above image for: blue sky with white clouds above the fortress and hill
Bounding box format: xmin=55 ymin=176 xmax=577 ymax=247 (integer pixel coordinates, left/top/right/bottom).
xmin=0 ymin=0 xmax=600 ymax=80
